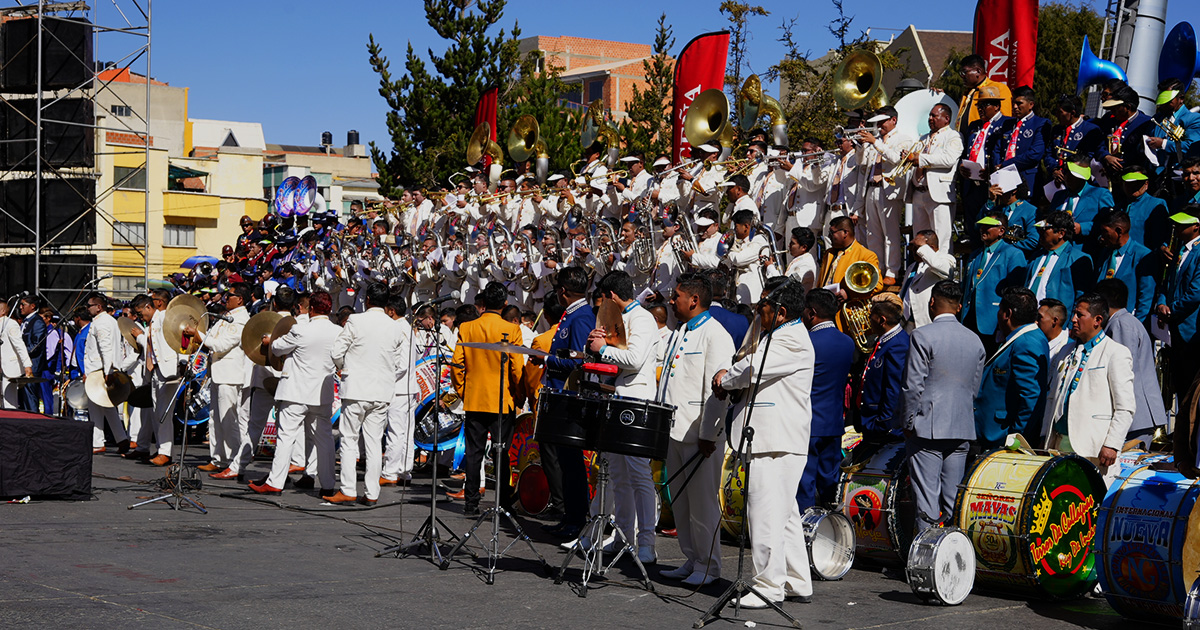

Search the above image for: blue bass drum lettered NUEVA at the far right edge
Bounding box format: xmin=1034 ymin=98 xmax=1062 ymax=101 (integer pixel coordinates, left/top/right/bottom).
xmin=1096 ymin=462 xmax=1200 ymax=623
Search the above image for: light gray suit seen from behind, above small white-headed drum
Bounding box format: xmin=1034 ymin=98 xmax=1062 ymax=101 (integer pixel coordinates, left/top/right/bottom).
xmin=896 ymin=314 xmax=986 ymax=530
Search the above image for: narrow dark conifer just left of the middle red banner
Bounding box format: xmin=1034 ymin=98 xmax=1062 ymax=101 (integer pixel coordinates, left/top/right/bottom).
xmin=619 ymin=13 xmax=674 ymax=160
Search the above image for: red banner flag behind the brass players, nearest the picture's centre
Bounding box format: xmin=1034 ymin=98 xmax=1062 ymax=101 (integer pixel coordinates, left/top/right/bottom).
xmin=671 ymin=31 xmax=730 ymax=164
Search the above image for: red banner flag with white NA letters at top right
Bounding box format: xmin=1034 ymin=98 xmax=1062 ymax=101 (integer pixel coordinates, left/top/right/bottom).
xmin=974 ymin=0 xmax=1038 ymax=89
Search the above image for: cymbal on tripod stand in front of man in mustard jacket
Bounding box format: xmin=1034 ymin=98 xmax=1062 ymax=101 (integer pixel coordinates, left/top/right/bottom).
xmin=442 ymin=332 xmax=548 ymax=584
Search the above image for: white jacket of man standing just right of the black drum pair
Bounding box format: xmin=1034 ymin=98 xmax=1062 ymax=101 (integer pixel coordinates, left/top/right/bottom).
xmin=656 ymin=312 xmax=736 ymax=444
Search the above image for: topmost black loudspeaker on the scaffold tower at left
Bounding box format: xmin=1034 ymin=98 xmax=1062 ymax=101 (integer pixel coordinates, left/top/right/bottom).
xmin=0 ymin=17 xmax=95 ymax=94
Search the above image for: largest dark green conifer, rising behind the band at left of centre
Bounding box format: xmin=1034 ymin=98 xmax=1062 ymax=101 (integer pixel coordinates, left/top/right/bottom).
xmin=367 ymin=0 xmax=521 ymax=197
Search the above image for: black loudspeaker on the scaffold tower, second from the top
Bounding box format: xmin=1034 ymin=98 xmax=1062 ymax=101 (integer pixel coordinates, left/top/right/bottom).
xmin=0 ymin=98 xmax=96 ymax=170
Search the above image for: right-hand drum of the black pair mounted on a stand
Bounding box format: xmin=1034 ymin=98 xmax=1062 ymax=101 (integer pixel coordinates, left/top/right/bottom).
xmin=595 ymin=395 xmax=674 ymax=460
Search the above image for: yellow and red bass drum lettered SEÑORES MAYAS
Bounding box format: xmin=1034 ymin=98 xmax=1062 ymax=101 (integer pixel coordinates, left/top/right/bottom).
xmin=954 ymin=449 xmax=1104 ymax=599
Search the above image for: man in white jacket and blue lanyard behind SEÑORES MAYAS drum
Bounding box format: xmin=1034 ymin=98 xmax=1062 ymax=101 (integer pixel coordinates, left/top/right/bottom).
xmin=1043 ymin=293 xmax=1138 ymax=474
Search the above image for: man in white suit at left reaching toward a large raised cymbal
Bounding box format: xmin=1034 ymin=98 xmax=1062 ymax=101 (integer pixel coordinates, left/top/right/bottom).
xmin=184 ymin=282 xmax=253 ymax=473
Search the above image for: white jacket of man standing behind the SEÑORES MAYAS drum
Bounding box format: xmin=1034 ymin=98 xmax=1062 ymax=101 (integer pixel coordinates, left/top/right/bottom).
xmin=1043 ymin=336 xmax=1138 ymax=457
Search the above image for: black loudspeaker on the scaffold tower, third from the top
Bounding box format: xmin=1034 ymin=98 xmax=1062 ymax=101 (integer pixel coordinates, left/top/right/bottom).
xmin=0 ymin=178 xmax=96 ymax=246
